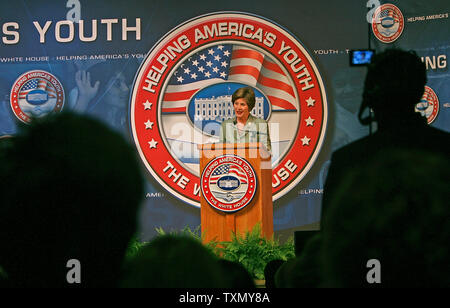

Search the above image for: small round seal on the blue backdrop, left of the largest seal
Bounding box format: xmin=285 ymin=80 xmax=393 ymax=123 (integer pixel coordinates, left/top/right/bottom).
xmin=10 ymin=70 xmax=64 ymax=123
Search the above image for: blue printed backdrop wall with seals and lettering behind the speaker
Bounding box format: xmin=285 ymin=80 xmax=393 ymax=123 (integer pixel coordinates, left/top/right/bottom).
xmin=0 ymin=0 xmax=450 ymax=239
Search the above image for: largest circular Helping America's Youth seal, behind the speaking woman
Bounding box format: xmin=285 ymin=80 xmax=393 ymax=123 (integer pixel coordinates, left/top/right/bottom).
xmin=130 ymin=12 xmax=327 ymax=207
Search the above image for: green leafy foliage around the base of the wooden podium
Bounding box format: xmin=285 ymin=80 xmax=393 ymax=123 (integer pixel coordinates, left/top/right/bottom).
xmin=140 ymin=224 xmax=295 ymax=279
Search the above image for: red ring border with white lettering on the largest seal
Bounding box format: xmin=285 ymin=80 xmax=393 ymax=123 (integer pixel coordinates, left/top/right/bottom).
xmin=130 ymin=11 xmax=328 ymax=207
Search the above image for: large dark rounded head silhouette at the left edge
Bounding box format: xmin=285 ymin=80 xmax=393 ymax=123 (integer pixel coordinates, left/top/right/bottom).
xmin=0 ymin=113 xmax=143 ymax=287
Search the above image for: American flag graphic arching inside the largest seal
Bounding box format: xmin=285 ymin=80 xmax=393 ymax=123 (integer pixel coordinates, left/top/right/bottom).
xmin=162 ymin=44 xmax=297 ymax=113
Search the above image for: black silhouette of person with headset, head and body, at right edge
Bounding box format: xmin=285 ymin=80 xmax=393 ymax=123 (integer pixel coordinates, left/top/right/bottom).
xmin=320 ymin=49 xmax=450 ymax=287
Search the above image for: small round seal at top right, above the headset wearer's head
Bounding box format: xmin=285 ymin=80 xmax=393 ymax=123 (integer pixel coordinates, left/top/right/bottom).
xmin=372 ymin=4 xmax=405 ymax=43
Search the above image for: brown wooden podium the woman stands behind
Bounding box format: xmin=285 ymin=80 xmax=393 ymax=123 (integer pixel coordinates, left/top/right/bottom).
xmin=198 ymin=143 xmax=273 ymax=243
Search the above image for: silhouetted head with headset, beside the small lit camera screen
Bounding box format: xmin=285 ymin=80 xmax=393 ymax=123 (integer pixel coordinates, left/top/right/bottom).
xmin=359 ymin=49 xmax=427 ymax=124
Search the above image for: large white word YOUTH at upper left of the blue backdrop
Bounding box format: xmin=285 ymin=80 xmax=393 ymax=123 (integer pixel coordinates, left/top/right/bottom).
xmin=32 ymin=18 xmax=141 ymax=44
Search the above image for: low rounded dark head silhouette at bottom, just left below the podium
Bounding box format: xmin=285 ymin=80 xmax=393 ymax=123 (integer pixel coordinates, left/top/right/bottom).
xmin=121 ymin=235 xmax=229 ymax=288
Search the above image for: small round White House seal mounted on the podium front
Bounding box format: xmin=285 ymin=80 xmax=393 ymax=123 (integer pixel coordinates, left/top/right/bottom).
xmin=201 ymin=155 xmax=257 ymax=212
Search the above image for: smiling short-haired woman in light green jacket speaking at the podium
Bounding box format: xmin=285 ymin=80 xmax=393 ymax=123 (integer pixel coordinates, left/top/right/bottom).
xmin=220 ymin=87 xmax=272 ymax=152
